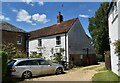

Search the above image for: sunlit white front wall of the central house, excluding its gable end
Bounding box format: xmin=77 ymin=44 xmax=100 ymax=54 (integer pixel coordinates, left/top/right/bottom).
xmin=29 ymin=34 xmax=67 ymax=60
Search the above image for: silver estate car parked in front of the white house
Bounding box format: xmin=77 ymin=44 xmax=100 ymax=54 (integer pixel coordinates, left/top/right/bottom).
xmin=8 ymin=58 xmax=64 ymax=79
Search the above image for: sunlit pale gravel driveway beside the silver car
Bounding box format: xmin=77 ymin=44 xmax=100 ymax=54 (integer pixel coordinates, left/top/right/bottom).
xmin=26 ymin=63 xmax=104 ymax=81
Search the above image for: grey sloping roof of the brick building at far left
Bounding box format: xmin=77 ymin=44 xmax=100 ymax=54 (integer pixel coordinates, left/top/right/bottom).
xmin=0 ymin=22 xmax=26 ymax=33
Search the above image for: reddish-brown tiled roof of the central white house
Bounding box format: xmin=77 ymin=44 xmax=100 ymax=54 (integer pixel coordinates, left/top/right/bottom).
xmin=30 ymin=18 xmax=78 ymax=39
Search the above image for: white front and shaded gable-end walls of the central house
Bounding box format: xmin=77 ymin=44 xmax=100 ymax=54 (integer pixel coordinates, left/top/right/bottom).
xmin=29 ymin=19 xmax=95 ymax=62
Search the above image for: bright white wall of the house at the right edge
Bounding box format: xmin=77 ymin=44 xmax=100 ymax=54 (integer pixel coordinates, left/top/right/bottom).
xmin=108 ymin=0 xmax=120 ymax=76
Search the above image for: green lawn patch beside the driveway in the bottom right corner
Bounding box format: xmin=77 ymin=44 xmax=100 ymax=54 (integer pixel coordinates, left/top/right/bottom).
xmin=92 ymin=70 xmax=120 ymax=83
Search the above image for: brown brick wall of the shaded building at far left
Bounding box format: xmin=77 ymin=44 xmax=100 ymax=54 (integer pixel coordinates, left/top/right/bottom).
xmin=2 ymin=31 xmax=27 ymax=52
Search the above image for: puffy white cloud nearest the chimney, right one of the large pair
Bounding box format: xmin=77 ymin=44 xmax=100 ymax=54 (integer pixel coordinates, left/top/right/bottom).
xmin=32 ymin=13 xmax=50 ymax=23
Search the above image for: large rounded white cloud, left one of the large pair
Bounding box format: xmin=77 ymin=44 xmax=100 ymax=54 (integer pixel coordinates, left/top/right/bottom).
xmin=16 ymin=9 xmax=32 ymax=24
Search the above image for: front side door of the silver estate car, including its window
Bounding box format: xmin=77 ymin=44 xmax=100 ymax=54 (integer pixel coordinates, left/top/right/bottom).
xmin=39 ymin=60 xmax=55 ymax=74
